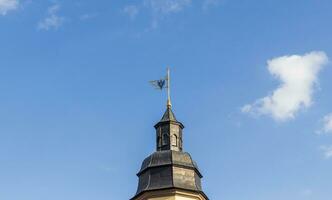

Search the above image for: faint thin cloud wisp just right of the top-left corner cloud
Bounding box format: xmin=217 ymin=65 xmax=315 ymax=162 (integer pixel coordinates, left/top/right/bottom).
xmin=38 ymin=4 xmax=64 ymax=30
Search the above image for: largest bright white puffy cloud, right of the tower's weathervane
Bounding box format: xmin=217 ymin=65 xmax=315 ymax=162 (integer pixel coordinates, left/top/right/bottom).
xmin=242 ymin=51 xmax=328 ymax=121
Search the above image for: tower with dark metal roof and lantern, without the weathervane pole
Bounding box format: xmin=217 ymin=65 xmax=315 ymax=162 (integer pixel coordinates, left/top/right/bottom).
xmin=131 ymin=101 xmax=208 ymax=200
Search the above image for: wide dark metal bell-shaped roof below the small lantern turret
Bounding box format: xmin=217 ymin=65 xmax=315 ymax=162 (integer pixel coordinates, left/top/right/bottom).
xmin=132 ymin=151 xmax=202 ymax=198
